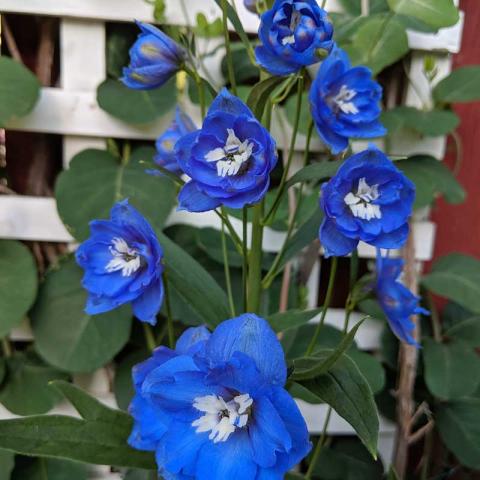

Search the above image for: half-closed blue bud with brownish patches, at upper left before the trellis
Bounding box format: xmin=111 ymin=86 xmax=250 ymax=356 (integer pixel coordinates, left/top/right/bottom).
xmin=121 ymin=22 xmax=186 ymax=90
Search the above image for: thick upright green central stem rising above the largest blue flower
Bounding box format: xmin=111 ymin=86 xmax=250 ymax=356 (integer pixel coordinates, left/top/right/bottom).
xmin=247 ymin=200 xmax=263 ymax=313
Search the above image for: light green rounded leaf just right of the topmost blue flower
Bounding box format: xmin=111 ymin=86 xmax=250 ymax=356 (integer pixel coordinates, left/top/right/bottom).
xmin=342 ymin=14 xmax=409 ymax=75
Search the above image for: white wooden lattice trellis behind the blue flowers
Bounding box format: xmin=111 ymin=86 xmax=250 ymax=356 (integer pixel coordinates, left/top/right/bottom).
xmin=0 ymin=0 xmax=463 ymax=480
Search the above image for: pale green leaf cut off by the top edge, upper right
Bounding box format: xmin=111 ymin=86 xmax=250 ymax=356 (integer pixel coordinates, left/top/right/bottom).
xmin=387 ymin=0 xmax=459 ymax=28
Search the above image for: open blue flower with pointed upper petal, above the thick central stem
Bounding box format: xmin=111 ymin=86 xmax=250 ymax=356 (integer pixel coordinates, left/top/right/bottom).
xmin=175 ymin=89 xmax=277 ymax=212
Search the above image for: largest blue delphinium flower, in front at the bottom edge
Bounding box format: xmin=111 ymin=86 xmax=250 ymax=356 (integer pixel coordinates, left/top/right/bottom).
xmin=129 ymin=314 xmax=311 ymax=480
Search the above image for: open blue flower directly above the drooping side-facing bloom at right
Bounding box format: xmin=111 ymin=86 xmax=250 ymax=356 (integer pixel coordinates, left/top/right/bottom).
xmin=320 ymin=146 xmax=415 ymax=256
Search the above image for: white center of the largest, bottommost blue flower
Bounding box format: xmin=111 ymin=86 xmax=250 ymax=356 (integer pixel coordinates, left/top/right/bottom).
xmin=192 ymin=393 xmax=253 ymax=443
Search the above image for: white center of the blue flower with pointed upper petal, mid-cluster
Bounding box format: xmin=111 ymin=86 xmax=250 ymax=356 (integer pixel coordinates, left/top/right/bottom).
xmin=205 ymin=128 xmax=253 ymax=177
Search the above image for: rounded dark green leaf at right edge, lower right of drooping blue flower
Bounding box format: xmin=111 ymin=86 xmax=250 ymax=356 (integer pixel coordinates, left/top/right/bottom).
xmin=423 ymin=338 xmax=480 ymax=400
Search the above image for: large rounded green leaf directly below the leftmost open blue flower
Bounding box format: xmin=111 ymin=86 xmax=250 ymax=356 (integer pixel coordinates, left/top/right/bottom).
xmin=31 ymin=258 xmax=132 ymax=372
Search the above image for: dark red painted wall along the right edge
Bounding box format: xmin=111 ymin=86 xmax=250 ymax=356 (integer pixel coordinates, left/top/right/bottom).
xmin=433 ymin=0 xmax=480 ymax=258
